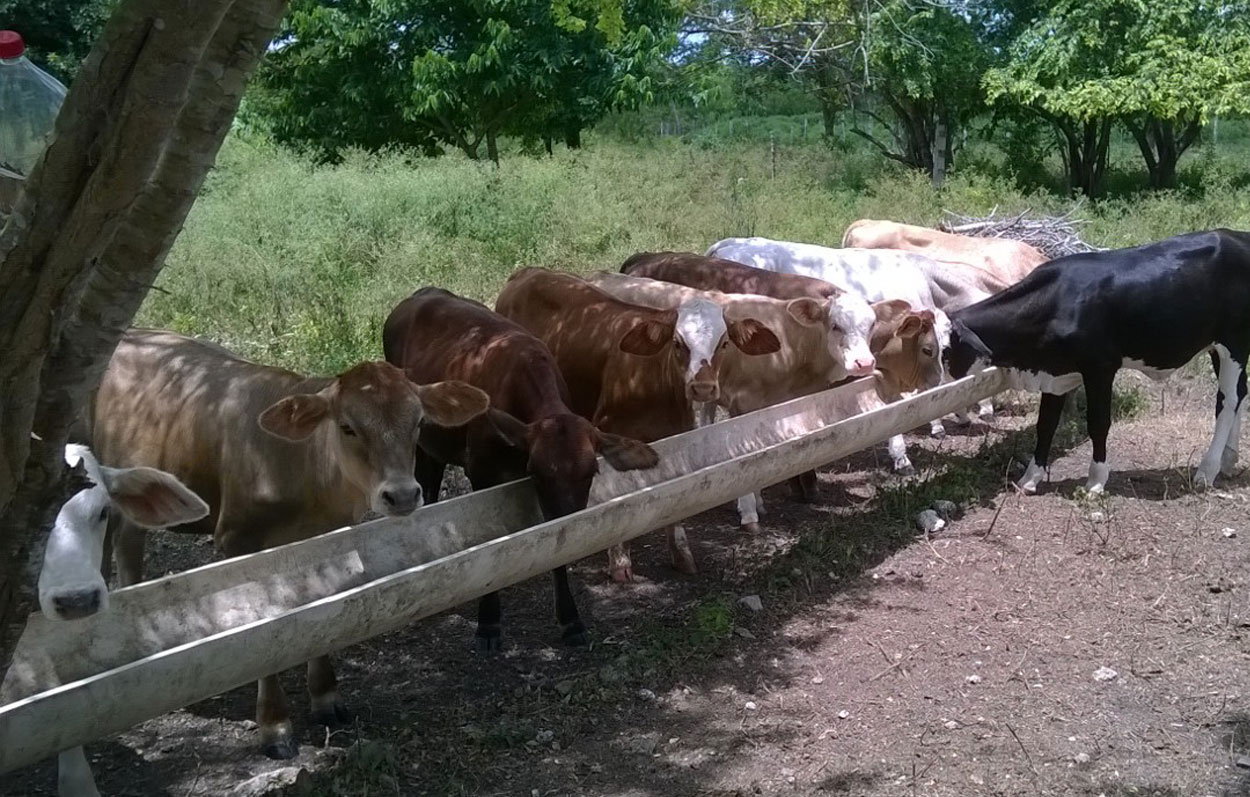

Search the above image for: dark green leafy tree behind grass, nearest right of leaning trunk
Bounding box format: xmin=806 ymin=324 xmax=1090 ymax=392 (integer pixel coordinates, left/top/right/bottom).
xmin=253 ymin=0 xmax=679 ymax=160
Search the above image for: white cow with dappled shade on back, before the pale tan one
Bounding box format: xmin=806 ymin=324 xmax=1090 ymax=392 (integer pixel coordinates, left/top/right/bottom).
xmin=708 ymin=237 xmax=993 ymax=437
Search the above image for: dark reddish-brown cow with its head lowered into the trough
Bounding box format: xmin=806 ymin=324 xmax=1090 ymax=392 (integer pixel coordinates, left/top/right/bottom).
xmin=383 ymin=287 xmax=659 ymax=652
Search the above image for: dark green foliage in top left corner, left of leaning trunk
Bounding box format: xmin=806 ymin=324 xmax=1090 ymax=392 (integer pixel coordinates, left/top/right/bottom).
xmin=0 ymin=0 xmax=118 ymax=84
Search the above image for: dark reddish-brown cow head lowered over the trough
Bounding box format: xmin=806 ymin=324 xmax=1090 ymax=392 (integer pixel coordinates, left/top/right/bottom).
xmin=490 ymin=408 xmax=660 ymax=520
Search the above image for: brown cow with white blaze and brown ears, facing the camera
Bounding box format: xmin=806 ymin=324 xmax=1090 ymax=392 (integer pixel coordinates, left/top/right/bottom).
xmin=495 ymin=269 xmax=781 ymax=582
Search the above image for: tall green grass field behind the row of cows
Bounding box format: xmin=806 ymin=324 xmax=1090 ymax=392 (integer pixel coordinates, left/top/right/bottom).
xmin=139 ymin=125 xmax=1250 ymax=374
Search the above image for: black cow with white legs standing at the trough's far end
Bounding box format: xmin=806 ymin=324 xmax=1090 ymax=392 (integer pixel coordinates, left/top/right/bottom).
xmin=945 ymin=230 xmax=1250 ymax=492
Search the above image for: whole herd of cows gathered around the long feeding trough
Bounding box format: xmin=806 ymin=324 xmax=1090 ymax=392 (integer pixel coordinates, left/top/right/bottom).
xmin=24 ymin=220 xmax=1250 ymax=795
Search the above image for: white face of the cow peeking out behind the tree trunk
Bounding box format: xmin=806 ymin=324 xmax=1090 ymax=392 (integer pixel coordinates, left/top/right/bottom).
xmin=39 ymin=443 xmax=110 ymax=620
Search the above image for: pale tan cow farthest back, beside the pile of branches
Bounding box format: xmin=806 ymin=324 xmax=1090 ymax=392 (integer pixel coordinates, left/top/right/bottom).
xmin=843 ymin=219 xmax=1048 ymax=288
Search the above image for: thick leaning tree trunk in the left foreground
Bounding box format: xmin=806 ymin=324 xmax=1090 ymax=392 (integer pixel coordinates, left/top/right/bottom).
xmin=0 ymin=0 xmax=285 ymax=678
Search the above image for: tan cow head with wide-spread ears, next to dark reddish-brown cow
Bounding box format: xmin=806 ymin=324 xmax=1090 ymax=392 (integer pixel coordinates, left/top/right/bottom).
xmin=260 ymin=362 xmax=490 ymax=517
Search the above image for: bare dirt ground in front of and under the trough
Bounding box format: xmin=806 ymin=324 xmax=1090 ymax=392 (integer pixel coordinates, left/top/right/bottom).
xmin=0 ymin=377 xmax=1250 ymax=797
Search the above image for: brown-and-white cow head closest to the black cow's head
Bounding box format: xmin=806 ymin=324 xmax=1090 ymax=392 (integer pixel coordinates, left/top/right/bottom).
xmin=873 ymin=300 xmax=943 ymax=392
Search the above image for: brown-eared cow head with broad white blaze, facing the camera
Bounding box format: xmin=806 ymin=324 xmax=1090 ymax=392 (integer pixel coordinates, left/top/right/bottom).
xmin=619 ymin=299 xmax=781 ymax=402
